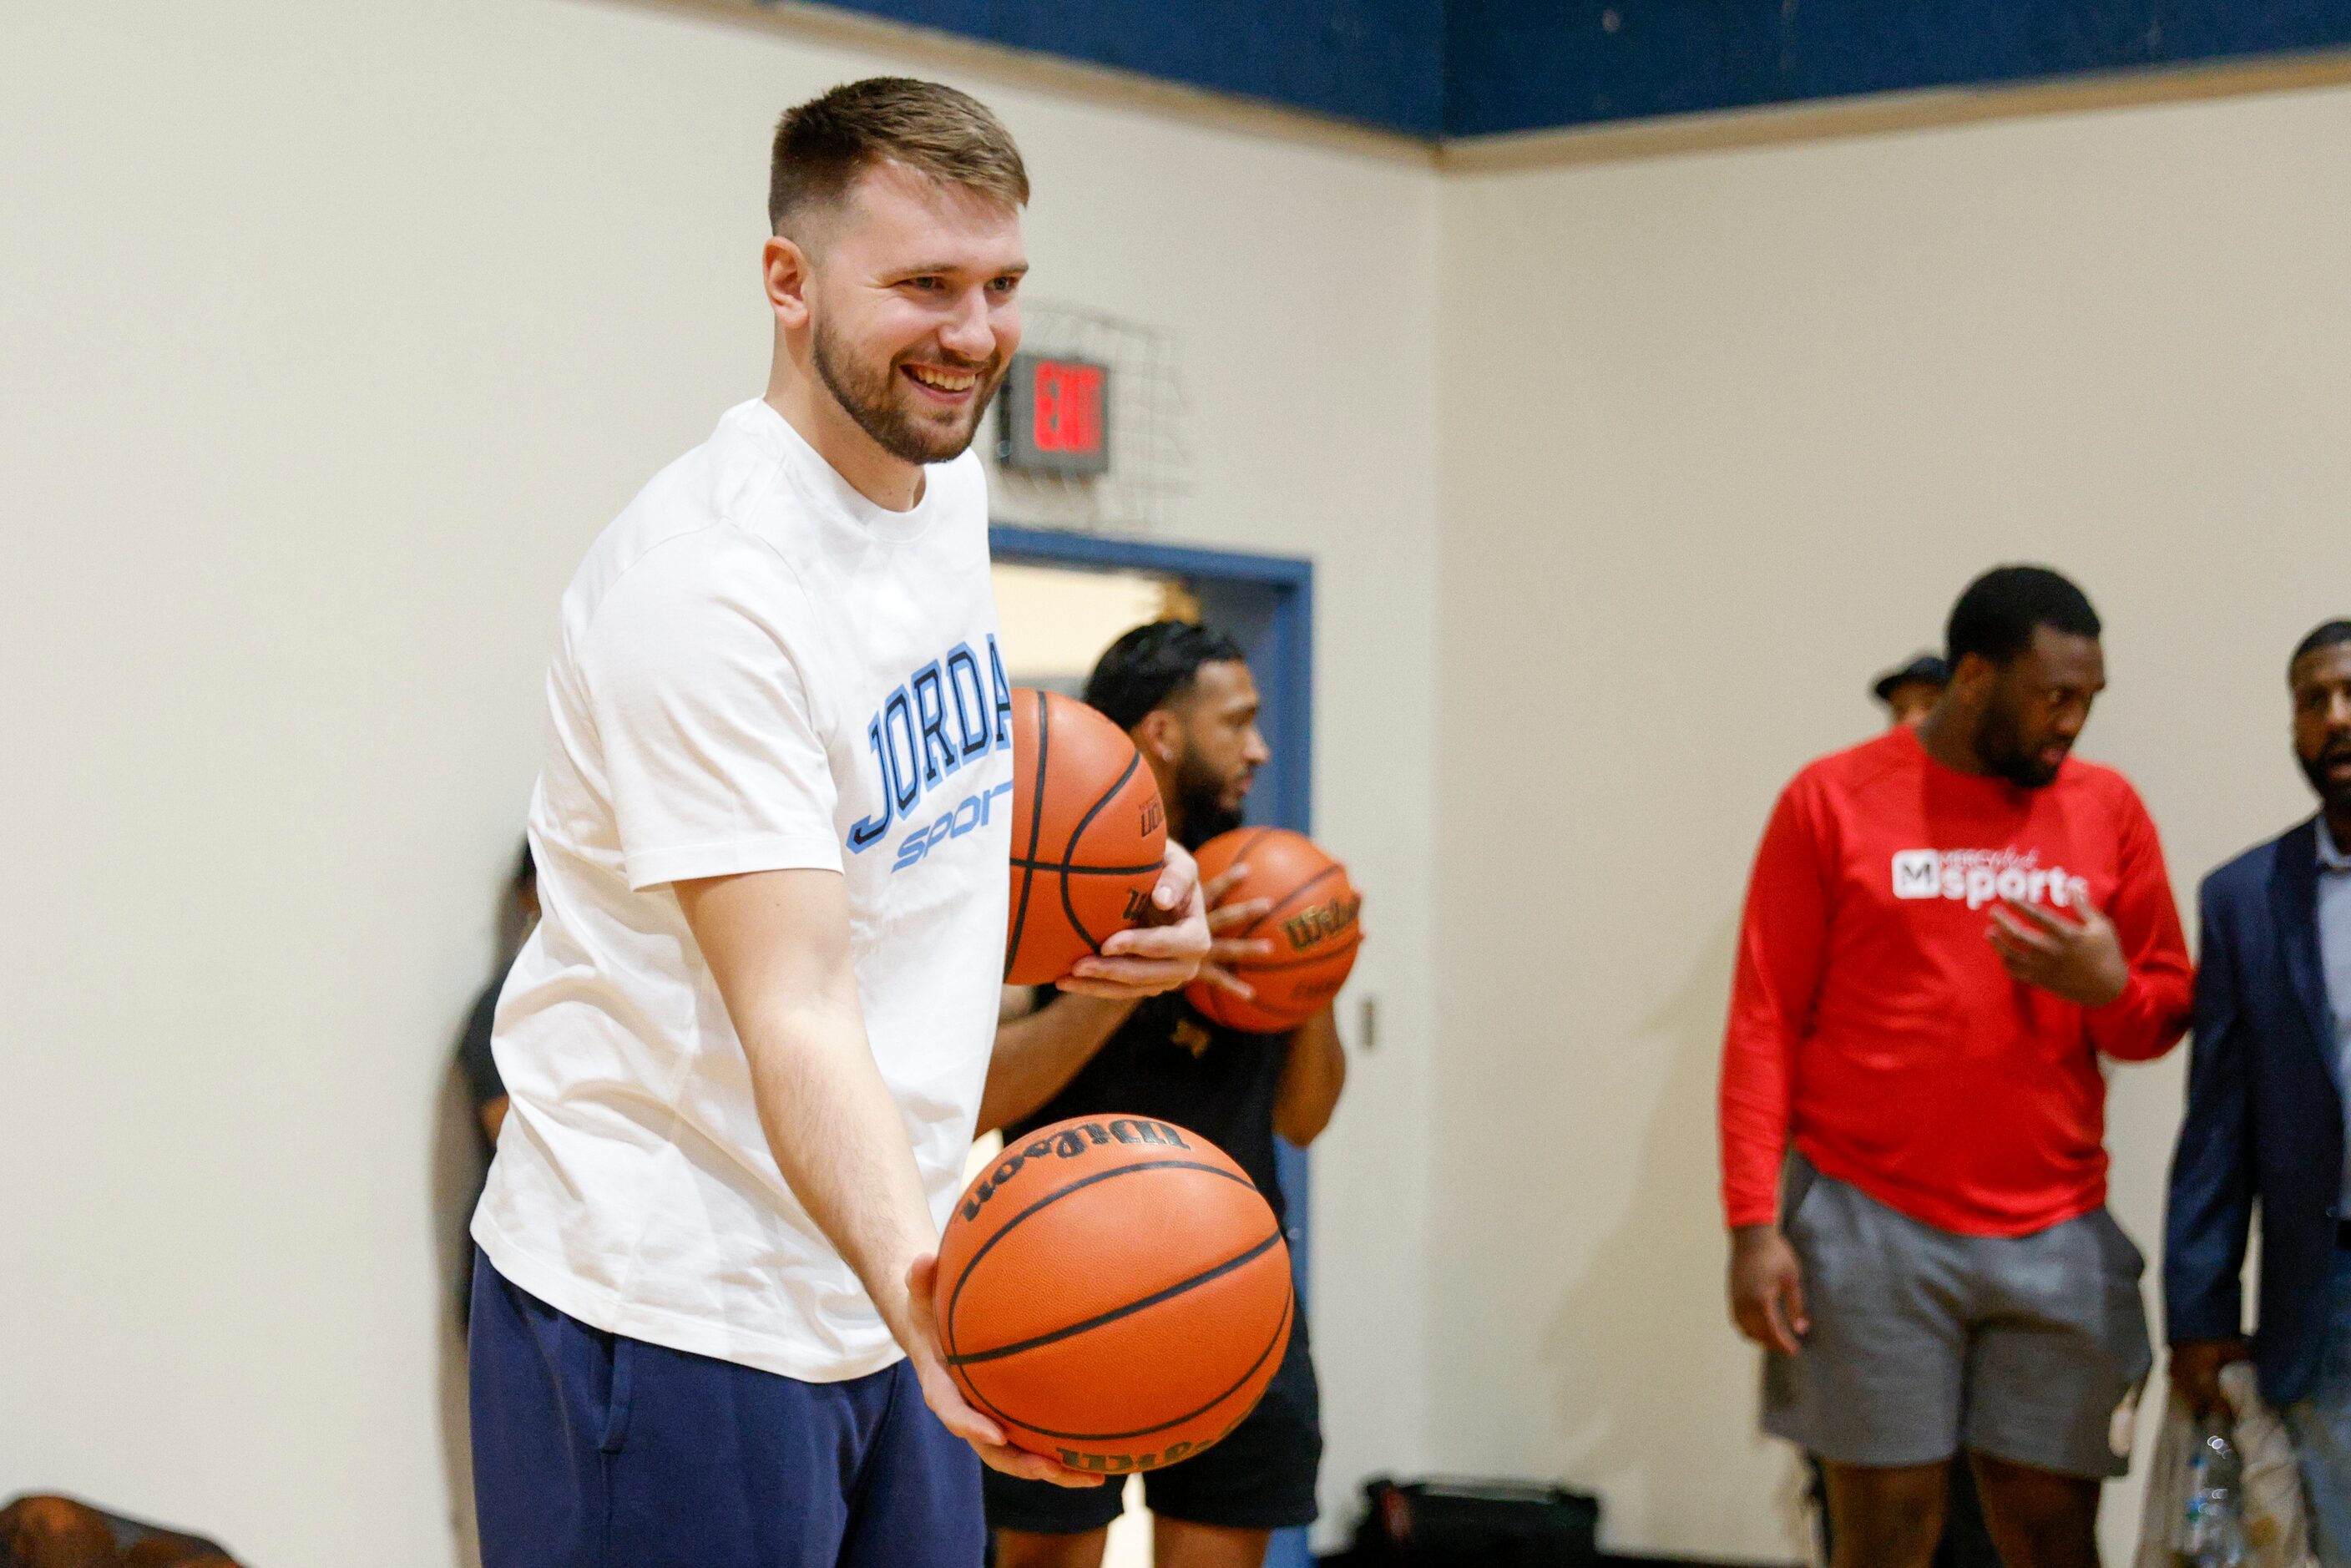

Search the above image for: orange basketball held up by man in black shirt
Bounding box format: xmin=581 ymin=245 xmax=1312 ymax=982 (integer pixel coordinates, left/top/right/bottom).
xmin=1185 ymin=827 xmax=1363 ymax=1034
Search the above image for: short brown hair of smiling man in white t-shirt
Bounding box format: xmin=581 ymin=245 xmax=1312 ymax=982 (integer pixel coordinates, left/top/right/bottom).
xmin=766 ymin=75 xmax=1028 ymax=235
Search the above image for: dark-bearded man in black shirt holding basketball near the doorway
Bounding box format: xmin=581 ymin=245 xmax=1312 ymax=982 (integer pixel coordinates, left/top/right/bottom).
xmin=980 ymin=620 xmax=1347 ymax=1568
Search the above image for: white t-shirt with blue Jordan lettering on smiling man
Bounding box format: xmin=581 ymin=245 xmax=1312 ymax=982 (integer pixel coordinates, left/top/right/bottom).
xmin=473 ymin=402 xmax=1014 ymax=1383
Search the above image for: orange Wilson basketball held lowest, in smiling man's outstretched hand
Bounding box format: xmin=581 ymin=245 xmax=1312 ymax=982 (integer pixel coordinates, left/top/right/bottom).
xmin=933 ymin=1116 xmax=1293 ymax=1474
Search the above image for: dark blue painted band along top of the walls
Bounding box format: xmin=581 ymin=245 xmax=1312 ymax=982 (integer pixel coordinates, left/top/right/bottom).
xmin=785 ymin=0 xmax=2351 ymax=139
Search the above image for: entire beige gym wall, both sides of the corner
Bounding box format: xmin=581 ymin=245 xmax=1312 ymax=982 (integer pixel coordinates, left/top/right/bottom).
xmin=18 ymin=0 xmax=2351 ymax=1568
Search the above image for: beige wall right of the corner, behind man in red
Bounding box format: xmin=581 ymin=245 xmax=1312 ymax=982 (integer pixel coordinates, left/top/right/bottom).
xmin=1429 ymin=79 xmax=2351 ymax=1554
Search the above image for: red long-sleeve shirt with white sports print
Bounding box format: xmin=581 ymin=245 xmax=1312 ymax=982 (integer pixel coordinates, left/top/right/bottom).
xmin=1721 ymin=729 xmax=2193 ymax=1237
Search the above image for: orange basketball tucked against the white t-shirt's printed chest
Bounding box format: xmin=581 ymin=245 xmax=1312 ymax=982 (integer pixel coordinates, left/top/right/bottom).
xmin=1004 ymin=686 xmax=1169 ymax=985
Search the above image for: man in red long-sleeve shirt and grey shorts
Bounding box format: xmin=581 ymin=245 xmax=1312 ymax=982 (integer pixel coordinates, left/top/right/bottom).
xmin=1721 ymin=567 xmax=2192 ymax=1568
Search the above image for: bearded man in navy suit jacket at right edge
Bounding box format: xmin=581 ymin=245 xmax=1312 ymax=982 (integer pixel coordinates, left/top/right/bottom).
xmin=2163 ymin=620 xmax=2351 ymax=1563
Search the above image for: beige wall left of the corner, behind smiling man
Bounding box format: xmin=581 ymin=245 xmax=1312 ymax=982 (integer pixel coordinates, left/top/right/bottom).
xmin=0 ymin=0 xmax=1437 ymax=1568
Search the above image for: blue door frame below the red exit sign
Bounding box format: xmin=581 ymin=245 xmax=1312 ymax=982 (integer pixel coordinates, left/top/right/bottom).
xmin=988 ymin=524 xmax=1314 ymax=1568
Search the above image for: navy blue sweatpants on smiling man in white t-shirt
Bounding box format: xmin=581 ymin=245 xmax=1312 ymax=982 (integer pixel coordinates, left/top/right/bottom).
xmin=470 ymin=1256 xmax=985 ymax=1568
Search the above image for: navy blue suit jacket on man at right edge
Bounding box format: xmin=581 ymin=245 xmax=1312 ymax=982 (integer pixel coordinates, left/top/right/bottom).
xmin=2163 ymin=818 xmax=2344 ymax=1406
